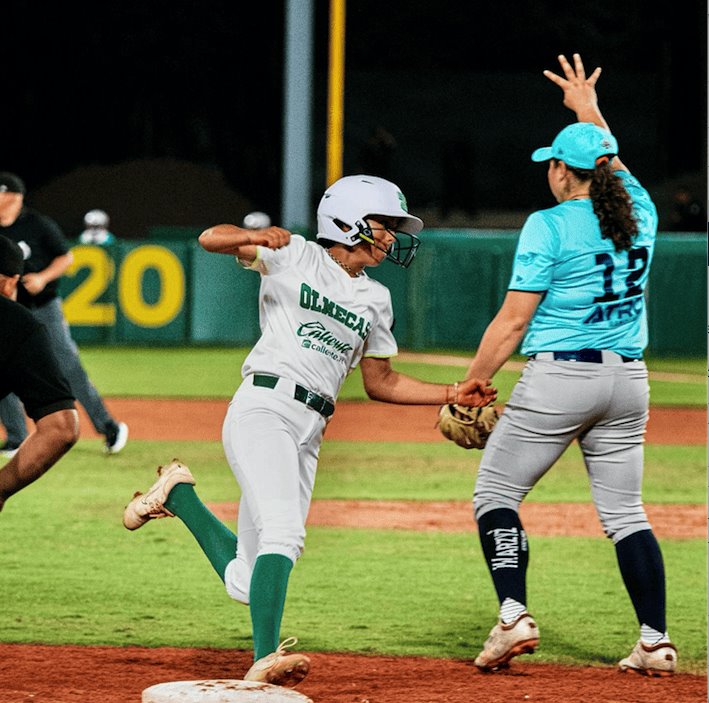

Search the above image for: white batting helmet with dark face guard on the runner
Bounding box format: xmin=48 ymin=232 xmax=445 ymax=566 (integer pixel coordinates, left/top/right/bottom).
xmin=317 ymin=175 xmax=423 ymax=267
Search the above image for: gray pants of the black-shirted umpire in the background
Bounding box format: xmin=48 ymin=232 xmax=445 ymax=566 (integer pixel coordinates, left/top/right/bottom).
xmin=0 ymin=298 xmax=113 ymax=444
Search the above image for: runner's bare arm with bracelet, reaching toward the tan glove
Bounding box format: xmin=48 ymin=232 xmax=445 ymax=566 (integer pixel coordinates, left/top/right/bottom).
xmin=360 ymin=357 xmax=497 ymax=407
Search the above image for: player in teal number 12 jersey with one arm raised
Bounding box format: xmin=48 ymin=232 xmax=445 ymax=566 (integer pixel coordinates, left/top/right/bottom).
xmin=468 ymin=54 xmax=677 ymax=676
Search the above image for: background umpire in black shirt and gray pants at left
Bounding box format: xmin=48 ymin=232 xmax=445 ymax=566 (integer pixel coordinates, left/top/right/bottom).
xmin=0 ymin=172 xmax=128 ymax=456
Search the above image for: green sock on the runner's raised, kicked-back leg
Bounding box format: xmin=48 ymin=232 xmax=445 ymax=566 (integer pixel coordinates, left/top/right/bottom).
xmin=165 ymin=483 xmax=237 ymax=581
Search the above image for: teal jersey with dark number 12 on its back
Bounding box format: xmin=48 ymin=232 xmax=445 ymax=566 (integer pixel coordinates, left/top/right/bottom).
xmin=509 ymin=171 xmax=657 ymax=357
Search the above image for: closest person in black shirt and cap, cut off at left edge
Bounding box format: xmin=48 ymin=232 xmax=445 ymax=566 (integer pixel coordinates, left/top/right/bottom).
xmin=0 ymin=236 xmax=79 ymax=510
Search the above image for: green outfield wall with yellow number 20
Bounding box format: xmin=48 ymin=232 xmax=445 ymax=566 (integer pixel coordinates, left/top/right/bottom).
xmin=60 ymin=230 xmax=707 ymax=356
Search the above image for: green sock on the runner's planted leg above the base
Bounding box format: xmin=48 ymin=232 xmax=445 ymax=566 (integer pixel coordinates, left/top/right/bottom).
xmin=249 ymin=554 xmax=293 ymax=661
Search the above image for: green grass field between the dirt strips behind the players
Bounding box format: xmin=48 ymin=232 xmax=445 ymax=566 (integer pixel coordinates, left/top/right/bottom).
xmin=0 ymin=349 xmax=707 ymax=673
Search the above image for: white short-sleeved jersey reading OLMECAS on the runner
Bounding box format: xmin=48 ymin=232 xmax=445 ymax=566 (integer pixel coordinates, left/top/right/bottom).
xmin=236 ymin=235 xmax=398 ymax=402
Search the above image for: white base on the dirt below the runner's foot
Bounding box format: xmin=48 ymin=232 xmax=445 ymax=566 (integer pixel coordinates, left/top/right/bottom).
xmin=142 ymin=679 xmax=313 ymax=703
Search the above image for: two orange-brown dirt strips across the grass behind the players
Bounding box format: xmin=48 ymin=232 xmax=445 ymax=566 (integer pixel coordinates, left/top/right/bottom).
xmin=90 ymin=399 xmax=707 ymax=538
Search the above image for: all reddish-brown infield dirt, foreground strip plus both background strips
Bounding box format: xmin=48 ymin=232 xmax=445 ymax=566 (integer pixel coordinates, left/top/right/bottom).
xmin=0 ymin=399 xmax=707 ymax=703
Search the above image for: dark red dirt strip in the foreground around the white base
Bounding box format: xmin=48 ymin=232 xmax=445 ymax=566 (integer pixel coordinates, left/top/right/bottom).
xmin=0 ymin=645 xmax=707 ymax=703
